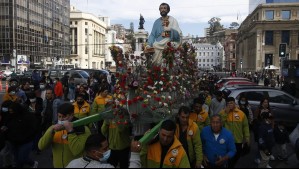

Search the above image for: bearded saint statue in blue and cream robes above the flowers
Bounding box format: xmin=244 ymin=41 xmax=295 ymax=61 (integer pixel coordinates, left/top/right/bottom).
xmin=145 ymin=3 xmax=182 ymax=65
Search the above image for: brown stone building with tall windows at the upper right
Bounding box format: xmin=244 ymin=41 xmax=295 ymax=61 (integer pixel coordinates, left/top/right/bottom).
xmin=236 ymin=3 xmax=299 ymax=71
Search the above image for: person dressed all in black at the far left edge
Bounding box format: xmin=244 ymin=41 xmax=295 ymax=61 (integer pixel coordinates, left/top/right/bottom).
xmin=2 ymin=102 xmax=38 ymax=168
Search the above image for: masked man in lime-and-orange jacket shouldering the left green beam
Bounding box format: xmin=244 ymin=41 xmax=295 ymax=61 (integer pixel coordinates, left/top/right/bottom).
xmin=38 ymin=103 xmax=91 ymax=168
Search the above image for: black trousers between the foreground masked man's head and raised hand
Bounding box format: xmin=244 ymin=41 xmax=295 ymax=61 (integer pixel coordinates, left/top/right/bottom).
xmin=108 ymin=147 xmax=130 ymax=168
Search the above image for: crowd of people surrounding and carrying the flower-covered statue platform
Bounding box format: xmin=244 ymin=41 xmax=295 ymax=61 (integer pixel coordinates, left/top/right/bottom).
xmin=0 ymin=67 xmax=289 ymax=168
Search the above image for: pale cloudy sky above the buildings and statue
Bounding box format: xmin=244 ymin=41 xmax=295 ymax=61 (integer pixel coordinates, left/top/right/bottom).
xmin=71 ymin=0 xmax=249 ymax=36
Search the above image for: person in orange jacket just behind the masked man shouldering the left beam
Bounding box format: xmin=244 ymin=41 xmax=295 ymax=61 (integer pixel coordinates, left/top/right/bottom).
xmin=74 ymin=94 xmax=90 ymax=119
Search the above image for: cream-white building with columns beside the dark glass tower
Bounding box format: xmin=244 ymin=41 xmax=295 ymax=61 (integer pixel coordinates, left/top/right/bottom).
xmin=69 ymin=7 xmax=107 ymax=69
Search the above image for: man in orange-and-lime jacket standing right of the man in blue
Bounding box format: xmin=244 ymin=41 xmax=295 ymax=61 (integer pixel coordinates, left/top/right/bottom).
xmin=219 ymin=97 xmax=250 ymax=168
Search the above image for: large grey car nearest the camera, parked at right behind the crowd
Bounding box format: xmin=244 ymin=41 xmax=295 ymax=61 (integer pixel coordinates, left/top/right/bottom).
xmin=220 ymin=85 xmax=299 ymax=128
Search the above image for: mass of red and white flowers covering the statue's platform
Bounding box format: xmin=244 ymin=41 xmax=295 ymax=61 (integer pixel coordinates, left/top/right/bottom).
xmin=109 ymin=43 xmax=199 ymax=124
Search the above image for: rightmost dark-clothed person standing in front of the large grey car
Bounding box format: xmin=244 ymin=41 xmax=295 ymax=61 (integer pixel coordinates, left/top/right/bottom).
xmin=274 ymin=121 xmax=290 ymax=161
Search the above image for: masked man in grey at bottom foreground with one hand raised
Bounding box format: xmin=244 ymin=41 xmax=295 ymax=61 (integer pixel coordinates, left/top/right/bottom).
xmin=66 ymin=134 xmax=141 ymax=168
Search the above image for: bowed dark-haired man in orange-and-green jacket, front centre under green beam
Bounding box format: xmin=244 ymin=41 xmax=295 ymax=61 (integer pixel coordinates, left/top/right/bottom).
xmin=140 ymin=120 xmax=190 ymax=168
